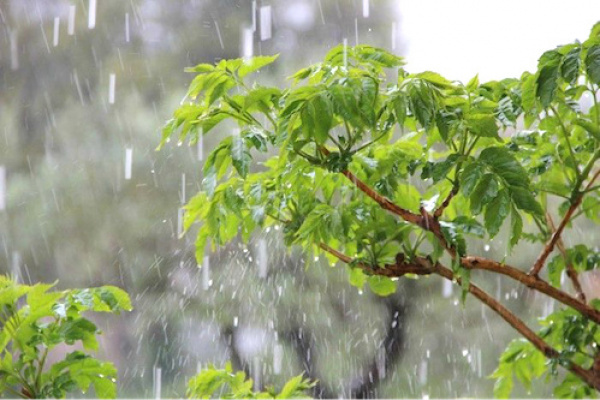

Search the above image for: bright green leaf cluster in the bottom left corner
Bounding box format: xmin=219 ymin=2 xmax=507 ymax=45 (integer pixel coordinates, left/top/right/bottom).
xmin=0 ymin=276 xmax=131 ymax=398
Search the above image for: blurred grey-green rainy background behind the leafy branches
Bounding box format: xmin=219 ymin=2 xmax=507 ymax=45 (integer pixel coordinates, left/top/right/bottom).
xmin=0 ymin=0 xmax=592 ymax=398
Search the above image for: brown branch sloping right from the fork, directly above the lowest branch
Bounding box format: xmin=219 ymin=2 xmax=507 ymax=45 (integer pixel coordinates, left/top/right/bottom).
xmin=461 ymin=256 xmax=600 ymax=324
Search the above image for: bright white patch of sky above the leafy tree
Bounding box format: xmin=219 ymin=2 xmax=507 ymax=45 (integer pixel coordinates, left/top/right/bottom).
xmin=398 ymin=0 xmax=600 ymax=82
